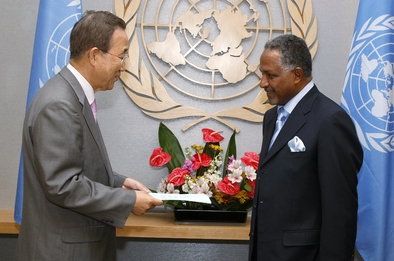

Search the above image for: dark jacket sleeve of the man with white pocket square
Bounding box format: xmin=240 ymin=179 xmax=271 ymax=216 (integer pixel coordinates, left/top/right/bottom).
xmin=318 ymin=111 xmax=363 ymax=260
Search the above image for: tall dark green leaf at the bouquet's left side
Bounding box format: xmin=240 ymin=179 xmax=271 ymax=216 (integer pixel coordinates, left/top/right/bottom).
xmin=159 ymin=122 xmax=185 ymax=173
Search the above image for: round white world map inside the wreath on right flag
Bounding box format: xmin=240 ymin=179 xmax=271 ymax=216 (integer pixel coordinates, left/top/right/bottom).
xmin=351 ymin=33 xmax=394 ymax=132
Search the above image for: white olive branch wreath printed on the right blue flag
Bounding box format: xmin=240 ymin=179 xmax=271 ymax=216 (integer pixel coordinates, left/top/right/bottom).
xmin=341 ymin=14 xmax=394 ymax=153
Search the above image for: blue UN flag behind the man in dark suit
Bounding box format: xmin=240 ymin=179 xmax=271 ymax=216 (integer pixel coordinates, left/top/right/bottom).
xmin=341 ymin=0 xmax=394 ymax=261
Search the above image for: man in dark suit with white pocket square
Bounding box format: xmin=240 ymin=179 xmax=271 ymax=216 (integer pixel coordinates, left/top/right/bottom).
xmin=249 ymin=35 xmax=363 ymax=261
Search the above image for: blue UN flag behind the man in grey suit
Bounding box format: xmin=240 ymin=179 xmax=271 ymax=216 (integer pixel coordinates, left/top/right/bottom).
xmin=14 ymin=0 xmax=82 ymax=224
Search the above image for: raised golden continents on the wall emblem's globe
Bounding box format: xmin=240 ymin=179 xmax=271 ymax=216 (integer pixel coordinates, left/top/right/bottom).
xmin=148 ymin=6 xmax=252 ymax=83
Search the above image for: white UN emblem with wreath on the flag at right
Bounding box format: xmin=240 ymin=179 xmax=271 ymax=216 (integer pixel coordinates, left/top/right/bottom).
xmin=345 ymin=15 xmax=394 ymax=153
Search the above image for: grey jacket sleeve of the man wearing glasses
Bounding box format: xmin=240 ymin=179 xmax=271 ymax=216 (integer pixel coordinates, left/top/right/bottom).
xmin=29 ymin=100 xmax=136 ymax=227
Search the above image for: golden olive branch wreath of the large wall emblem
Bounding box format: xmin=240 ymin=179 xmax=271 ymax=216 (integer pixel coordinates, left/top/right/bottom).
xmin=115 ymin=0 xmax=318 ymax=132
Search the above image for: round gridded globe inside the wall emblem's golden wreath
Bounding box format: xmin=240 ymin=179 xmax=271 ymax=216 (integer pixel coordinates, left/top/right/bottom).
xmin=141 ymin=0 xmax=287 ymax=100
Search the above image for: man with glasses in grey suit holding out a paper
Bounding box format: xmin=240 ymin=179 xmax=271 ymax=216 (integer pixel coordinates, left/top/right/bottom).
xmin=16 ymin=11 xmax=163 ymax=261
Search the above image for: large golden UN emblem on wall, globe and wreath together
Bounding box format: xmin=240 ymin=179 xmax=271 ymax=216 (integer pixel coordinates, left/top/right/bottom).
xmin=115 ymin=0 xmax=318 ymax=132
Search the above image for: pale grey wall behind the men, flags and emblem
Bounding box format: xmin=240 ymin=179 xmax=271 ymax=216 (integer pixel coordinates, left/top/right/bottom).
xmin=0 ymin=0 xmax=359 ymax=209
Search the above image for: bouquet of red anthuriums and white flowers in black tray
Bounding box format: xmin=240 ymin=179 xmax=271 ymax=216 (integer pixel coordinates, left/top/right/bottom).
xmin=149 ymin=123 xmax=259 ymax=218
